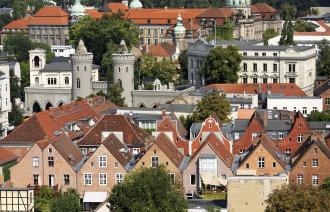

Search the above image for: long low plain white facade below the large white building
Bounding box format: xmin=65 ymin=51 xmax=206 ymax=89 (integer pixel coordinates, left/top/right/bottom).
xmin=267 ymin=96 xmax=323 ymax=116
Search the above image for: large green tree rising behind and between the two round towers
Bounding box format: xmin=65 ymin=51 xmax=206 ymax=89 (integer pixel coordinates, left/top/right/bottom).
xmin=70 ymin=13 xmax=139 ymax=68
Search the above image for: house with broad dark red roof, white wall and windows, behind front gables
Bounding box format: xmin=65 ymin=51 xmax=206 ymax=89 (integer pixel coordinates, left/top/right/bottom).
xmin=77 ymin=115 xmax=150 ymax=155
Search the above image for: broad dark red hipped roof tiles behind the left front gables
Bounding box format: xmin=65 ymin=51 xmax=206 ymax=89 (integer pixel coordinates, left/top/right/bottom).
xmin=78 ymin=115 xmax=149 ymax=146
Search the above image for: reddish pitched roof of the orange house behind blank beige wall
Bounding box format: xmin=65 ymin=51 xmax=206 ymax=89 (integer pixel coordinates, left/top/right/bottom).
xmin=239 ymin=133 xmax=287 ymax=169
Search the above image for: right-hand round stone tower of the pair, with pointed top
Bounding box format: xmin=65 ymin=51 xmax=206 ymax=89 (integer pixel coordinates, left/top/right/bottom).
xmin=112 ymin=40 xmax=135 ymax=107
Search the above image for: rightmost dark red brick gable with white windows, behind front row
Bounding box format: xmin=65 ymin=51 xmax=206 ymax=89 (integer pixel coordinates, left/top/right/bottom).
xmin=276 ymin=111 xmax=311 ymax=155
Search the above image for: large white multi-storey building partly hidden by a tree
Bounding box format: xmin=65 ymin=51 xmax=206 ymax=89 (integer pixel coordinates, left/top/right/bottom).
xmin=188 ymin=40 xmax=316 ymax=95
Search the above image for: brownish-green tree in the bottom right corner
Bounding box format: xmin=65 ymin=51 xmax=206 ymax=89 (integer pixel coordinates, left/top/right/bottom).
xmin=266 ymin=185 xmax=330 ymax=212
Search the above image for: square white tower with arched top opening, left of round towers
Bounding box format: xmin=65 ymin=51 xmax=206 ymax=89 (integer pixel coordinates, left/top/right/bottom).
xmin=29 ymin=49 xmax=46 ymax=86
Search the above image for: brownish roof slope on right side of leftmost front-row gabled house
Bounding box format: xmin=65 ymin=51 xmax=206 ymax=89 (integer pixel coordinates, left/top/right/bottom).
xmin=51 ymin=133 xmax=84 ymax=167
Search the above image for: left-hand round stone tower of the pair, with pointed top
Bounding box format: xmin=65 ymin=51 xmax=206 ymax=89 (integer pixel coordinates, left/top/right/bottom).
xmin=71 ymin=40 xmax=93 ymax=100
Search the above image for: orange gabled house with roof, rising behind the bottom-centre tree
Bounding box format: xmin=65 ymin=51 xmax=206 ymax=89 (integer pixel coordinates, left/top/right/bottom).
xmin=134 ymin=133 xmax=187 ymax=181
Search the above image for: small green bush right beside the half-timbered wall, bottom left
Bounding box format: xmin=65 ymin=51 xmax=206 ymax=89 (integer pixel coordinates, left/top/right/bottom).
xmin=34 ymin=186 xmax=56 ymax=212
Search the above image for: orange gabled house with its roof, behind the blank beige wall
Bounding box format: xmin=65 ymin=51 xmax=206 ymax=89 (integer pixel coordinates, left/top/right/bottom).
xmin=236 ymin=133 xmax=289 ymax=176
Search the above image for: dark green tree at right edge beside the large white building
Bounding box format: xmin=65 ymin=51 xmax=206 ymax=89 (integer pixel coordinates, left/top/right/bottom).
xmin=316 ymin=40 xmax=330 ymax=77
